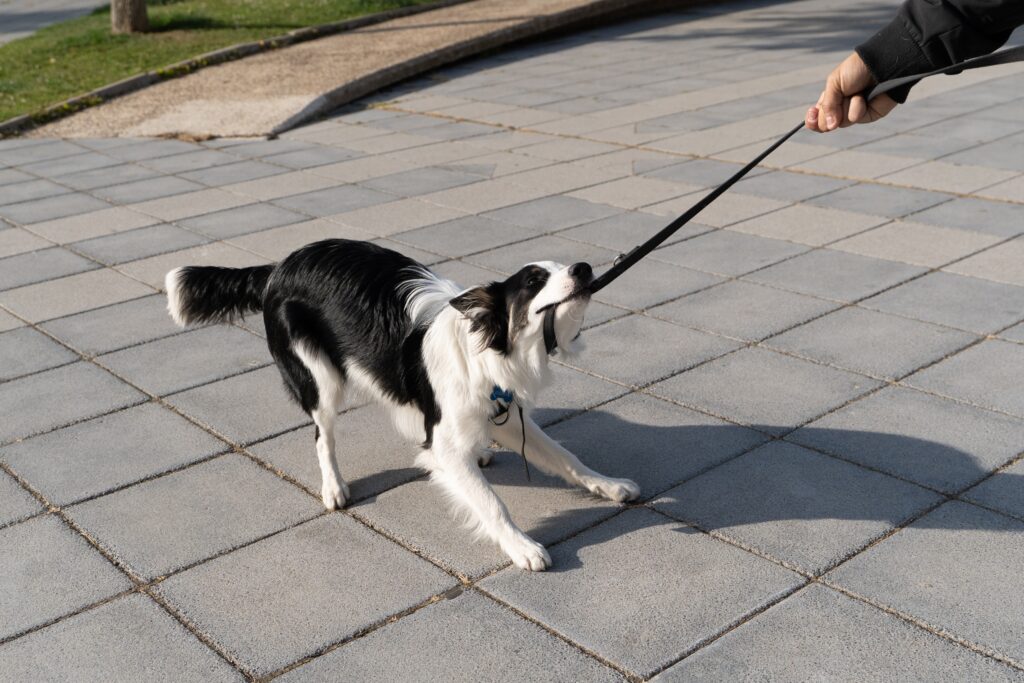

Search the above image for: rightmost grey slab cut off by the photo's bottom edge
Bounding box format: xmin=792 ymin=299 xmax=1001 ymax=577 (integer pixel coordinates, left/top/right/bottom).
xmin=654 ymin=585 xmax=1024 ymax=683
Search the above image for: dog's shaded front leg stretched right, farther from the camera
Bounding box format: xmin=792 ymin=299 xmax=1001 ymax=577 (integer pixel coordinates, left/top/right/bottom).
xmin=490 ymin=411 xmax=640 ymax=502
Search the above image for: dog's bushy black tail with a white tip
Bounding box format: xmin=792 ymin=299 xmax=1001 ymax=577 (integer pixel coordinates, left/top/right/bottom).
xmin=164 ymin=265 xmax=273 ymax=327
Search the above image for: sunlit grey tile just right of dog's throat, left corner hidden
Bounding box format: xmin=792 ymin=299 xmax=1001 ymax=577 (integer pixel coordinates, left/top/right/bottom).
xmin=565 ymin=315 xmax=739 ymax=386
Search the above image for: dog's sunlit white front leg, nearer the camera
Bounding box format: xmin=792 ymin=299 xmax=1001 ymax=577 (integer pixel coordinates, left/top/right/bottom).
xmin=421 ymin=429 xmax=551 ymax=571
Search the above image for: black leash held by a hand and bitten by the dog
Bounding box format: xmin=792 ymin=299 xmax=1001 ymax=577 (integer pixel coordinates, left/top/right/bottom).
xmin=542 ymin=45 xmax=1024 ymax=354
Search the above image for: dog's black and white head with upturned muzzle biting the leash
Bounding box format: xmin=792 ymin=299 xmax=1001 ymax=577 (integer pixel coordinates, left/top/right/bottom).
xmin=452 ymin=261 xmax=594 ymax=355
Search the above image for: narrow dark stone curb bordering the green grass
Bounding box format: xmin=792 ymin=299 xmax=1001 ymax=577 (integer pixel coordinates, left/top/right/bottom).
xmin=0 ymin=0 xmax=472 ymax=138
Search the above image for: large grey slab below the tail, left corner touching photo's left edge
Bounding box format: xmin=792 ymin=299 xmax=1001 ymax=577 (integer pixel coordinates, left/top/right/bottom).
xmin=0 ymin=403 xmax=227 ymax=506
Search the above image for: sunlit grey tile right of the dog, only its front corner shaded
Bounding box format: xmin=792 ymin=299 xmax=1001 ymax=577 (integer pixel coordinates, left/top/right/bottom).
xmin=650 ymin=348 xmax=880 ymax=434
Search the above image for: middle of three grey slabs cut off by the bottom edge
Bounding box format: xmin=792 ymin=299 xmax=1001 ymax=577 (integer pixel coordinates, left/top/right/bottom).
xmin=281 ymin=591 xmax=623 ymax=683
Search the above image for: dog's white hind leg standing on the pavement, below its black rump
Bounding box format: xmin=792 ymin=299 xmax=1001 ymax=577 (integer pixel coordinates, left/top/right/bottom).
xmin=292 ymin=342 xmax=349 ymax=510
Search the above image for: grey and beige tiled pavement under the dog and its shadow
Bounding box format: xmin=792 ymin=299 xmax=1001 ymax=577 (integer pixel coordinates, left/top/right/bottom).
xmin=0 ymin=0 xmax=1024 ymax=682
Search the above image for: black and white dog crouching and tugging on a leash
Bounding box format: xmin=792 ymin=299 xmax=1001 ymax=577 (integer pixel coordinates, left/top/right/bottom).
xmin=166 ymin=240 xmax=640 ymax=571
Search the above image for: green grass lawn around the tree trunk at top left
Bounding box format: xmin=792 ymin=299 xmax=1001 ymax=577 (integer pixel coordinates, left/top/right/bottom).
xmin=0 ymin=0 xmax=434 ymax=121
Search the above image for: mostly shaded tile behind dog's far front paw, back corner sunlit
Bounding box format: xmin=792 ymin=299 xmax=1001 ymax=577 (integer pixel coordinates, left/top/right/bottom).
xmin=549 ymin=394 xmax=767 ymax=499
